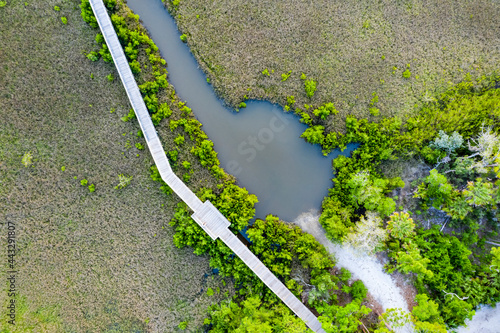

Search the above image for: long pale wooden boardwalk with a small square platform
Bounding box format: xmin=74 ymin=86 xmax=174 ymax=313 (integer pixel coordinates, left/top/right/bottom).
xmin=90 ymin=0 xmax=325 ymax=333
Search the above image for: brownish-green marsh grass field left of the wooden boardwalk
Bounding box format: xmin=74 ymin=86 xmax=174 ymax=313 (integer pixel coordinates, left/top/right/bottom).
xmin=0 ymin=0 xmax=232 ymax=333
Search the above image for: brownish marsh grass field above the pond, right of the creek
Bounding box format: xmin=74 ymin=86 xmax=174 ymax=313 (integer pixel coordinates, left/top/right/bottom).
xmin=166 ymin=0 xmax=500 ymax=129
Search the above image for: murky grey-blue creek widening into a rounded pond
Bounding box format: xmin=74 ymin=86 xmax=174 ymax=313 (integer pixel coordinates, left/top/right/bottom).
xmin=127 ymin=0 xmax=355 ymax=221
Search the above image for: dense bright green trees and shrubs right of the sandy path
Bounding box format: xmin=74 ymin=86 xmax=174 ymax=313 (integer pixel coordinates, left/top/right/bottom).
xmin=296 ymin=75 xmax=500 ymax=329
